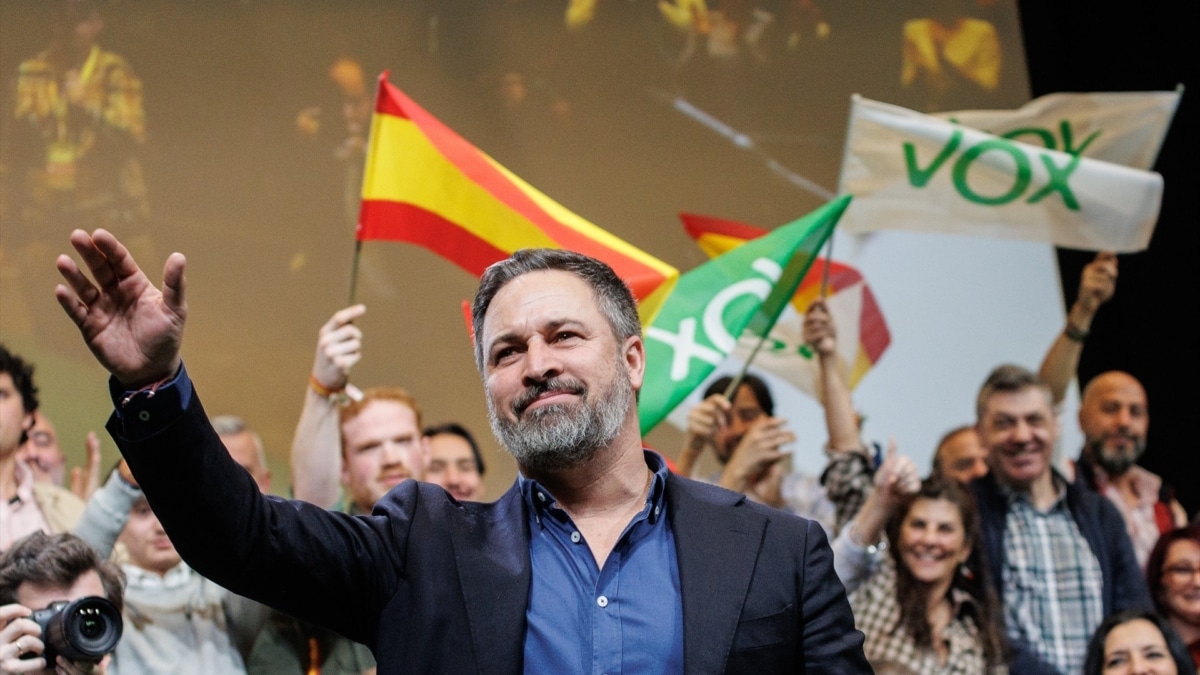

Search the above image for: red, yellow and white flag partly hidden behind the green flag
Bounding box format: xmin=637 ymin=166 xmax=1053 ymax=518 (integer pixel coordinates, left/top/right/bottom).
xmin=680 ymin=214 xmax=892 ymax=398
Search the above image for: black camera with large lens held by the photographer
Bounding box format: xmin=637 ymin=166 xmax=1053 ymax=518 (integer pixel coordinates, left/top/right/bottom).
xmin=26 ymin=596 xmax=125 ymax=668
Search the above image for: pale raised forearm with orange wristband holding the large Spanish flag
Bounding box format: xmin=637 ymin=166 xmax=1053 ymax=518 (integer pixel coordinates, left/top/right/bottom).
xmin=292 ymin=305 xmax=366 ymax=508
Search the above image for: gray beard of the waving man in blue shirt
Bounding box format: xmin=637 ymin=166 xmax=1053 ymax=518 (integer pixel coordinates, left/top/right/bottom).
xmin=487 ymin=365 xmax=634 ymax=471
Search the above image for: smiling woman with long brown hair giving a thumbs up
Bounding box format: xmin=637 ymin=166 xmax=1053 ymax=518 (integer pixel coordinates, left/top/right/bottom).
xmin=834 ymin=456 xmax=1007 ymax=674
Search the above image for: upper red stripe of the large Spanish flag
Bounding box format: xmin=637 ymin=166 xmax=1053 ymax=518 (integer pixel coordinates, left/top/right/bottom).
xmin=376 ymin=79 xmax=662 ymax=289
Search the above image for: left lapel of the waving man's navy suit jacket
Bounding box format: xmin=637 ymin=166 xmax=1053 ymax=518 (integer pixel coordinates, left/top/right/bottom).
xmin=451 ymin=485 xmax=532 ymax=673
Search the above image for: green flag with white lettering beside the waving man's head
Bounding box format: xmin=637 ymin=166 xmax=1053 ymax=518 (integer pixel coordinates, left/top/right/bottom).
xmin=637 ymin=196 xmax=851 ymax=436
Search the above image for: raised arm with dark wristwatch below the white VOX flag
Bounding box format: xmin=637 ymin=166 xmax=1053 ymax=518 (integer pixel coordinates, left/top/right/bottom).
xmin=1038 ymin=251 xmax=1117 ymax=405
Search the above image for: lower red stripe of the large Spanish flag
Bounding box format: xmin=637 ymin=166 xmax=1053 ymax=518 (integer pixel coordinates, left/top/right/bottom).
xmin=358 ymin=199 xmax=509 ymax=277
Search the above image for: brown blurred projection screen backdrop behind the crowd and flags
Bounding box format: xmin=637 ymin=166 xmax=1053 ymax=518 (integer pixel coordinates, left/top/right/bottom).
xmin=0 ymin=0 xmax=1028 ymax=489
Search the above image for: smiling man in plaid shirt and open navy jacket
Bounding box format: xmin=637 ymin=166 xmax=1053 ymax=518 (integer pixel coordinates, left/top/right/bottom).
xmin=971 ymin=365 xmax=1151 ymax=675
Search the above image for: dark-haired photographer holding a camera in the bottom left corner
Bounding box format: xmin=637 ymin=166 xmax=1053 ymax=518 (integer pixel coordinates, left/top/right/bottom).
xmin=0 ymin=532 xmax=125 ymax=675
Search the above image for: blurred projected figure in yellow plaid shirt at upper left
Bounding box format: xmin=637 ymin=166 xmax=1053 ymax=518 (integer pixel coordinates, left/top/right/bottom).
xmin=4 ymin=0 xmax=149 ymax=237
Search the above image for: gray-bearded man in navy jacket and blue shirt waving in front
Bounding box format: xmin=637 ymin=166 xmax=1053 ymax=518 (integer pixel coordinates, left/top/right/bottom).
xmin=55 ymin=229 xmax=871 ymax=674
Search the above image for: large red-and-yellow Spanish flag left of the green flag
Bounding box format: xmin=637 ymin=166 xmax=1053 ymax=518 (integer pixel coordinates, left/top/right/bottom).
xmin=358 ymin=72 xmax=679 ymax=324
